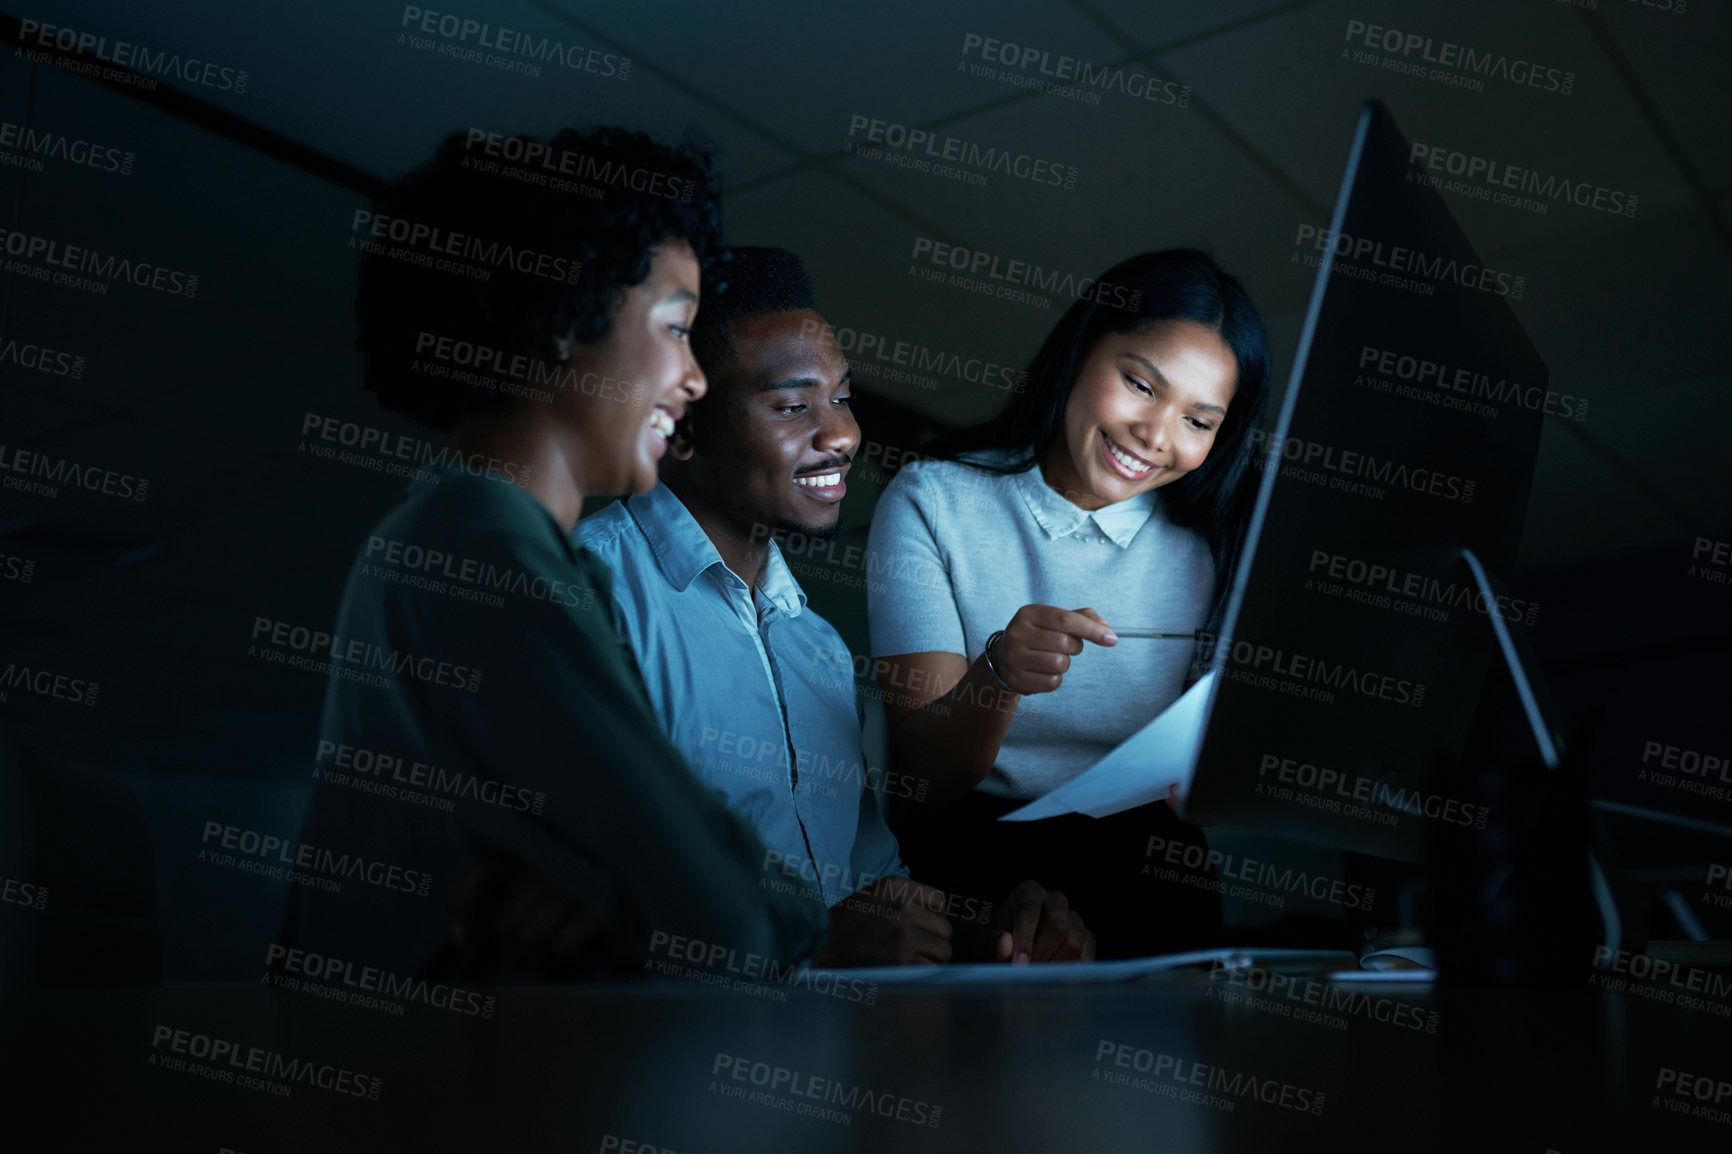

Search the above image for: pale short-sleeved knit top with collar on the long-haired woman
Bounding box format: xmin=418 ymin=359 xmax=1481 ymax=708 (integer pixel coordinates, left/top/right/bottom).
xmin=866 ymin=451 xmax=1214 ymax=799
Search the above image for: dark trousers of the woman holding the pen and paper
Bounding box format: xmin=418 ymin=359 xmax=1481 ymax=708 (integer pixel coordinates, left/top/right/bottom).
xmin=890 ymin=790 xmax=1221 ymax=958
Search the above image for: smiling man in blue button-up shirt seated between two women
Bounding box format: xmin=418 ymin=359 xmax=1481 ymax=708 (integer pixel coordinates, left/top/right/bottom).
xmin=577 ymin=248 xmax=1093 ymax=965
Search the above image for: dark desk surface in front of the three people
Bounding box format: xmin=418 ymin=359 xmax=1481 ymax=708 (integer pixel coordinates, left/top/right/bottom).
xmin=0 ymin=974 xmax=1732 ymax=1154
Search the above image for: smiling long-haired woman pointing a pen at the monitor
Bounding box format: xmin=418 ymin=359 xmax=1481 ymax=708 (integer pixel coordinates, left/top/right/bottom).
xmin=869 ymin=250 xmax=1270 ymax=956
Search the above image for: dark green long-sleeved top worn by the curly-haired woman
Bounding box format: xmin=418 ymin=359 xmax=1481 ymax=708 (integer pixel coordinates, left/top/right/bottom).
xmin=286 ymin=470 xmax=824 ymax=974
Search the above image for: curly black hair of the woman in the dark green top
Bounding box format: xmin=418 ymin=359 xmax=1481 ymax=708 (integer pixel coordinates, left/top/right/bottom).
xmin=352 ymin=126 xmax=722 ymax=430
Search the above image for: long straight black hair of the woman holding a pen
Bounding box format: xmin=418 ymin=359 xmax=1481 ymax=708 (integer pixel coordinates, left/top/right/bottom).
xmin=921 ymin=248 xmax=1270 ymax=634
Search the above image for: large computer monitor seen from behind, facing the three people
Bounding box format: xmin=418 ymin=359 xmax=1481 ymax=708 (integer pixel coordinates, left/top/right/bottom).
xmin=1181 ymin=100 xmax=1567 ymax=861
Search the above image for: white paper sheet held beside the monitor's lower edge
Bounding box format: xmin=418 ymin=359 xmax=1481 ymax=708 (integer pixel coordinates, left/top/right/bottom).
xmin=999 ymin=672 xmax=1216 ymax=821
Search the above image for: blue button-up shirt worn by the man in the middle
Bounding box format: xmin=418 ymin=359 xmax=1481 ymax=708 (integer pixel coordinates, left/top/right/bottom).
xmin=575 ymin=483 xmax=908 ymax=906
